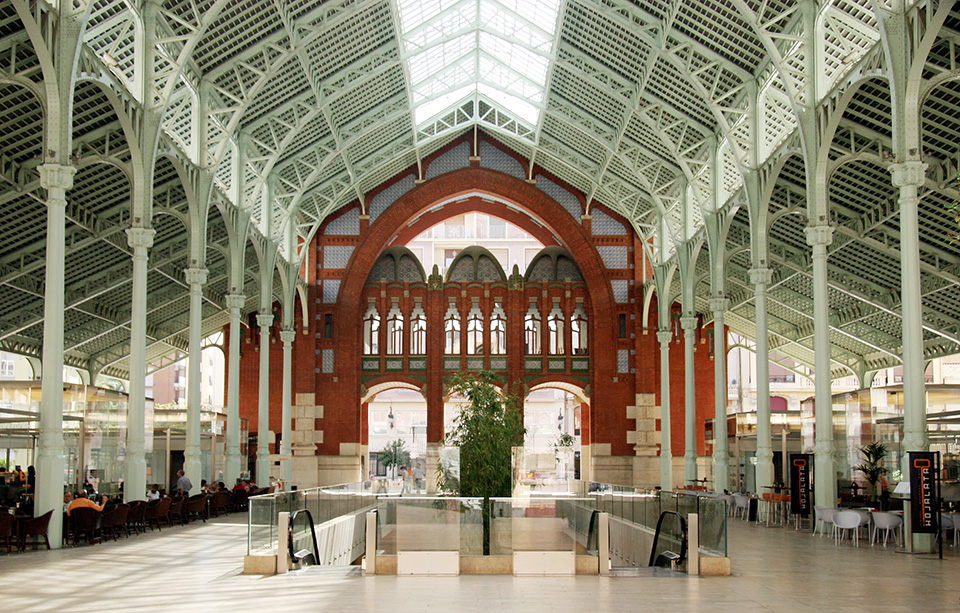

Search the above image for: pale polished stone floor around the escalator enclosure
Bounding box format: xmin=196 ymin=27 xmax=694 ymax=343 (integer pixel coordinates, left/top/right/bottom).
xmin=0 ymin=515 xmax=960 ymax=613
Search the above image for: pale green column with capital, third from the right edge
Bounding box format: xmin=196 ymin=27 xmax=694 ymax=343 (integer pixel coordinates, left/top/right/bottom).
xmin=750 ymin=268 xmax=774 ymax=493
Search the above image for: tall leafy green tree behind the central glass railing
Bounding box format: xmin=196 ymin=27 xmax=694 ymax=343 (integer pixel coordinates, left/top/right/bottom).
xmin=438 ymin=371 xmax=525 ymax=555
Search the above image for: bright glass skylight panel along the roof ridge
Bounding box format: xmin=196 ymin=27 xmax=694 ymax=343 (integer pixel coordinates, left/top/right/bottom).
xmin=396 ymin=0 xmax=563 ymax=127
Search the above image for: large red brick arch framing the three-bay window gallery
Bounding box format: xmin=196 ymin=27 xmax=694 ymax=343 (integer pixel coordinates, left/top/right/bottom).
xmin=324 ymin=167 xmax=616 ymax=451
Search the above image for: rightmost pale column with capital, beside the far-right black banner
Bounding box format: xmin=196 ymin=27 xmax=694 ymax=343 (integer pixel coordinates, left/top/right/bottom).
xmin=890 ymin=162 xmax=930 ymax=474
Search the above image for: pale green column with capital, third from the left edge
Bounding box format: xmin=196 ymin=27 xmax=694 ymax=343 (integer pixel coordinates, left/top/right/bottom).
xmin=183 ymin=268 xmax=207 ymax=494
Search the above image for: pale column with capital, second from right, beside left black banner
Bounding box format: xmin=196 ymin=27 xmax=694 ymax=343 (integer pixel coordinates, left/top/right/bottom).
xmin=806 ymin=226 xmax=837 ymax=507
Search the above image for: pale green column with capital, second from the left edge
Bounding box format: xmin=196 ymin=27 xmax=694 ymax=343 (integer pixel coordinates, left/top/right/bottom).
xmin=123 ymin=227 xmax=156 ymax=502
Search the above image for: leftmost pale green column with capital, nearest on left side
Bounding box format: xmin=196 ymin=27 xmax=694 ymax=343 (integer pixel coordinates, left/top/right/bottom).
xmin=33 ymin=164 xmax=75 ymax=549
